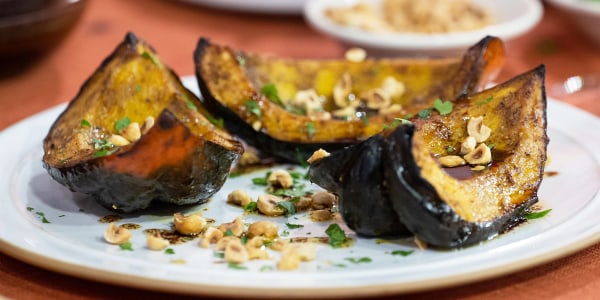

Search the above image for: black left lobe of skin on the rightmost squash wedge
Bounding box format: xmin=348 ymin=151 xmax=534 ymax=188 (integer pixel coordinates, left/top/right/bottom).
xmin=309 ymin=135 xmax=410 ymax=236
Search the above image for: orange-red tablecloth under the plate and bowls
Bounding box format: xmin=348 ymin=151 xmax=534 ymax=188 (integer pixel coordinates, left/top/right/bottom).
xmin=0 ymin=0 xmax=600 ymax=299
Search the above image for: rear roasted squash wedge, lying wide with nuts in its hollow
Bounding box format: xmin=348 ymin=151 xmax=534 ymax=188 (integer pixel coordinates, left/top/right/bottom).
xmin=194 ymin=37 xmax=504 ymax=163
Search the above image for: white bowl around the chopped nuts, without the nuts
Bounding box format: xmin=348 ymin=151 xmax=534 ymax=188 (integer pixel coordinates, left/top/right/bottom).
xmin=304 ymin=0 xmax=543 ymax=57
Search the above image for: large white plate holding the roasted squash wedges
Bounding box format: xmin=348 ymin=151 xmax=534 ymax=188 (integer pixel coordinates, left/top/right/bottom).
xmin=0 ymin=78 xmax=600 ymax=298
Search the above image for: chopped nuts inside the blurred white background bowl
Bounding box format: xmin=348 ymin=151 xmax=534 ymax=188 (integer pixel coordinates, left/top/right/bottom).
xmin=325 ymin=0 xmax=493 ymax=33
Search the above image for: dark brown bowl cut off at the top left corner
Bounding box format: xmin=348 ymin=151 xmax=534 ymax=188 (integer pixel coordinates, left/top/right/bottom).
xmin=0 ymin=0 xmax=86 ymax=76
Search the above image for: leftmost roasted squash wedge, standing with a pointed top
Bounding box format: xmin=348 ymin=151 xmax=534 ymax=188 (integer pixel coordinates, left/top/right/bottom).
xmin=43 ymin=33 xmax=243 ymax=212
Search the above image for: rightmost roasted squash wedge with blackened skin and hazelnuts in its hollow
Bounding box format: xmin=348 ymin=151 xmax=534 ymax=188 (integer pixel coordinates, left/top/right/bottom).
xmin=309 ymin=66 xmax=548 ymax=248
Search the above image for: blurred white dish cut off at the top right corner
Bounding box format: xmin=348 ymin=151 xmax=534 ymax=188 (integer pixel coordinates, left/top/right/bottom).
xmin=547 ymin=0 xmax=600 ymax=47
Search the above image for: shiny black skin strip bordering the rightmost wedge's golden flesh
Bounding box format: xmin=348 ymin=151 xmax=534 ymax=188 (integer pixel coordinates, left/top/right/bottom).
xmin=383 ymin=124 xmax=538 ymax=248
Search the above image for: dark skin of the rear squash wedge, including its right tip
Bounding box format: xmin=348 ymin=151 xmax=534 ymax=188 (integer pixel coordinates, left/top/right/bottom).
xmin=194 ymin=36 xmax=504 ymax=164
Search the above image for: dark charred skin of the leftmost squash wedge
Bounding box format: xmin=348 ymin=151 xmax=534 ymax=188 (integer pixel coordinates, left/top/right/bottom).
xmin=43 ymin=110 xmax=239 ymax=213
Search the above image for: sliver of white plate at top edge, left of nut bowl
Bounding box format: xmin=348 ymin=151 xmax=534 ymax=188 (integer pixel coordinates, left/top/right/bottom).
xmin=175 ymin=0 xmax=305 ymax=15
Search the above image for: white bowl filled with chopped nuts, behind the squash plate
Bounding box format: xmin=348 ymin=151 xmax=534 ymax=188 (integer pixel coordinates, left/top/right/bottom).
xmin=304 ymin=0 xmax=543 ymax=56
